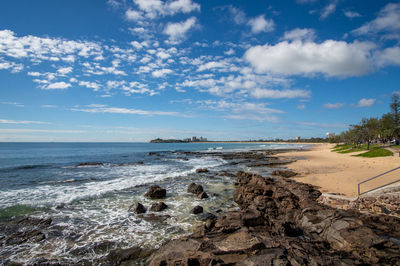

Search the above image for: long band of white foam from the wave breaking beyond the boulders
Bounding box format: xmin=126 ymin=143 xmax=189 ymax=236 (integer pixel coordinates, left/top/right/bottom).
xmin=0 ymin=157 xmax=224 ymax=208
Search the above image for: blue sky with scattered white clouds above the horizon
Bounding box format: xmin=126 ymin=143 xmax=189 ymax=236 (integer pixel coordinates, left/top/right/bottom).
xmin=0 ymin=0 xmax=400 ymax=141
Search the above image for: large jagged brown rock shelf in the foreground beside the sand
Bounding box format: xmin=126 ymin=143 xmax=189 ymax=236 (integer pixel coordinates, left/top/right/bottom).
xmin=147 ymin=172 xmax=400 ymax=265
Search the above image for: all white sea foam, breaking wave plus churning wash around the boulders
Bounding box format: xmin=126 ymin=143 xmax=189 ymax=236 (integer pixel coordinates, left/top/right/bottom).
xmin=1 ymin=157 xmax=234 ymax=264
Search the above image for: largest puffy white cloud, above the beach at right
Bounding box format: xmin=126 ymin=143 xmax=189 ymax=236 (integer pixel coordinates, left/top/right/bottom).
xmin=244 ymin=40 xmax=374 ymax=77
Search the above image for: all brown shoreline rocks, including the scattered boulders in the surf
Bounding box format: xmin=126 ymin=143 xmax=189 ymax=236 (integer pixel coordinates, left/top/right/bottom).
xmin=0 ymin=151 xmax=400 ymax=265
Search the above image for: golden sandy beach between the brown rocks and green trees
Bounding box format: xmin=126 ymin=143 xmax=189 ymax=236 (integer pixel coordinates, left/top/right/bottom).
xmin=278 ymin=144 xmax=400 ymax=197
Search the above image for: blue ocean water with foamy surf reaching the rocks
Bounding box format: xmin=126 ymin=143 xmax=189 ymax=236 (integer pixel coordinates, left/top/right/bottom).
xmin=0 ymin=143 xmax=299 ymax=263
